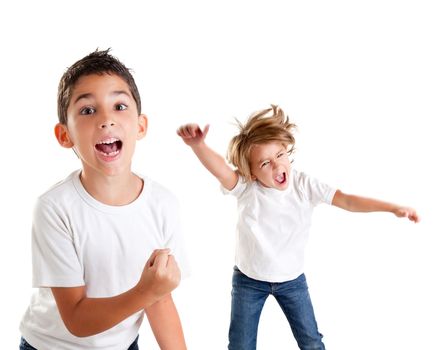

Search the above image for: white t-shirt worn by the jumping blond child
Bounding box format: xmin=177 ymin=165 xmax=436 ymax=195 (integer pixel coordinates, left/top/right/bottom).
xmin=222 ymin=169 xmax=336 ymax=283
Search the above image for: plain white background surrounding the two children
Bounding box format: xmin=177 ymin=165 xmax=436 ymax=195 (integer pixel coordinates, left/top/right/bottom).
xmin=0 ymin=0 xmax=437 ymax=350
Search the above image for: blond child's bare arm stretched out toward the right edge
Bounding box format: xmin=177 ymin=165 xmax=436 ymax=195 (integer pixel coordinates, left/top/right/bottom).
xmin=332 ymin=190 xmax=419 ymax=223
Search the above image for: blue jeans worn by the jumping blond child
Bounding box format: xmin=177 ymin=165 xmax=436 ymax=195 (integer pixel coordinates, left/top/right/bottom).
xmin=228 ymin=267 xmax=325 ymax=350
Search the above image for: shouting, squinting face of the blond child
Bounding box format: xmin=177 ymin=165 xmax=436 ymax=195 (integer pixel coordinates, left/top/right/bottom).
xmin=249 ymin=141 xmax=290 ymax=191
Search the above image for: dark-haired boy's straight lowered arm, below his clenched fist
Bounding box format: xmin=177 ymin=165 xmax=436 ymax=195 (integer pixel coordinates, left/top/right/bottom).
xmin=145 ymin=294 xmax=187 ymax=350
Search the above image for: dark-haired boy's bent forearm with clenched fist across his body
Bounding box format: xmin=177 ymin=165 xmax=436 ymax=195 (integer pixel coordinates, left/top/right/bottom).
xmin=51 ymin=249 xmax=180 ymax=337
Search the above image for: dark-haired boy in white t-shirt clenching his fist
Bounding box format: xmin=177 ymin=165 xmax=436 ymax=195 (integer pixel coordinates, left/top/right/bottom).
xmin=20 ymin=50 xmax=186 ymax=350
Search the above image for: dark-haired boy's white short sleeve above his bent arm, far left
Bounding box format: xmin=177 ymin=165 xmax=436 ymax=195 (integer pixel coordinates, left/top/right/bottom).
xmin=32 ymin=199 xmax=85 ymax=287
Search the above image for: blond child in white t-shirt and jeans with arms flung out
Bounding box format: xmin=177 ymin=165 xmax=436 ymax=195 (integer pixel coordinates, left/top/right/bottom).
xmin=178 ymin=106 xmax=419 ymax=350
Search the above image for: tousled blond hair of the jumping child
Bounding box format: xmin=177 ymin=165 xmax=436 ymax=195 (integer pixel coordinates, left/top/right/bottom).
xmin=227 ymin=105 xmax=296 ymax=181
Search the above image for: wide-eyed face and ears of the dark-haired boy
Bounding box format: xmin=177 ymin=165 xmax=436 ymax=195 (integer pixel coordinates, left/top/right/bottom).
xmin=55 ymin=74 xmax=147 ymax=176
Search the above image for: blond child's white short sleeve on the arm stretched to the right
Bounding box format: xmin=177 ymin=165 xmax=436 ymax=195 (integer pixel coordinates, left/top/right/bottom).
xmin=299 ymin=173 xmax=336 ymax=206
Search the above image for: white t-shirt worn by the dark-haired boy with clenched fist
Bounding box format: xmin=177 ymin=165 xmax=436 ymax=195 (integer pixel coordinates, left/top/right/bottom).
xmin=20 ymin=171 xmax=188 ymax=350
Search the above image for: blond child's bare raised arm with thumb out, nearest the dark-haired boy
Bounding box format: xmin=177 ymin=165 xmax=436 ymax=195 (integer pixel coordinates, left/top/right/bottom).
xmin=177 ymin=124 xmax=238 ymax=190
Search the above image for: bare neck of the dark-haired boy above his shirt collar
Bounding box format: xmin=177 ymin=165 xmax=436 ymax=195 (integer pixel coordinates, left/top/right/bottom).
xmin=80 ymin=170 xmax=143 ymax=206
